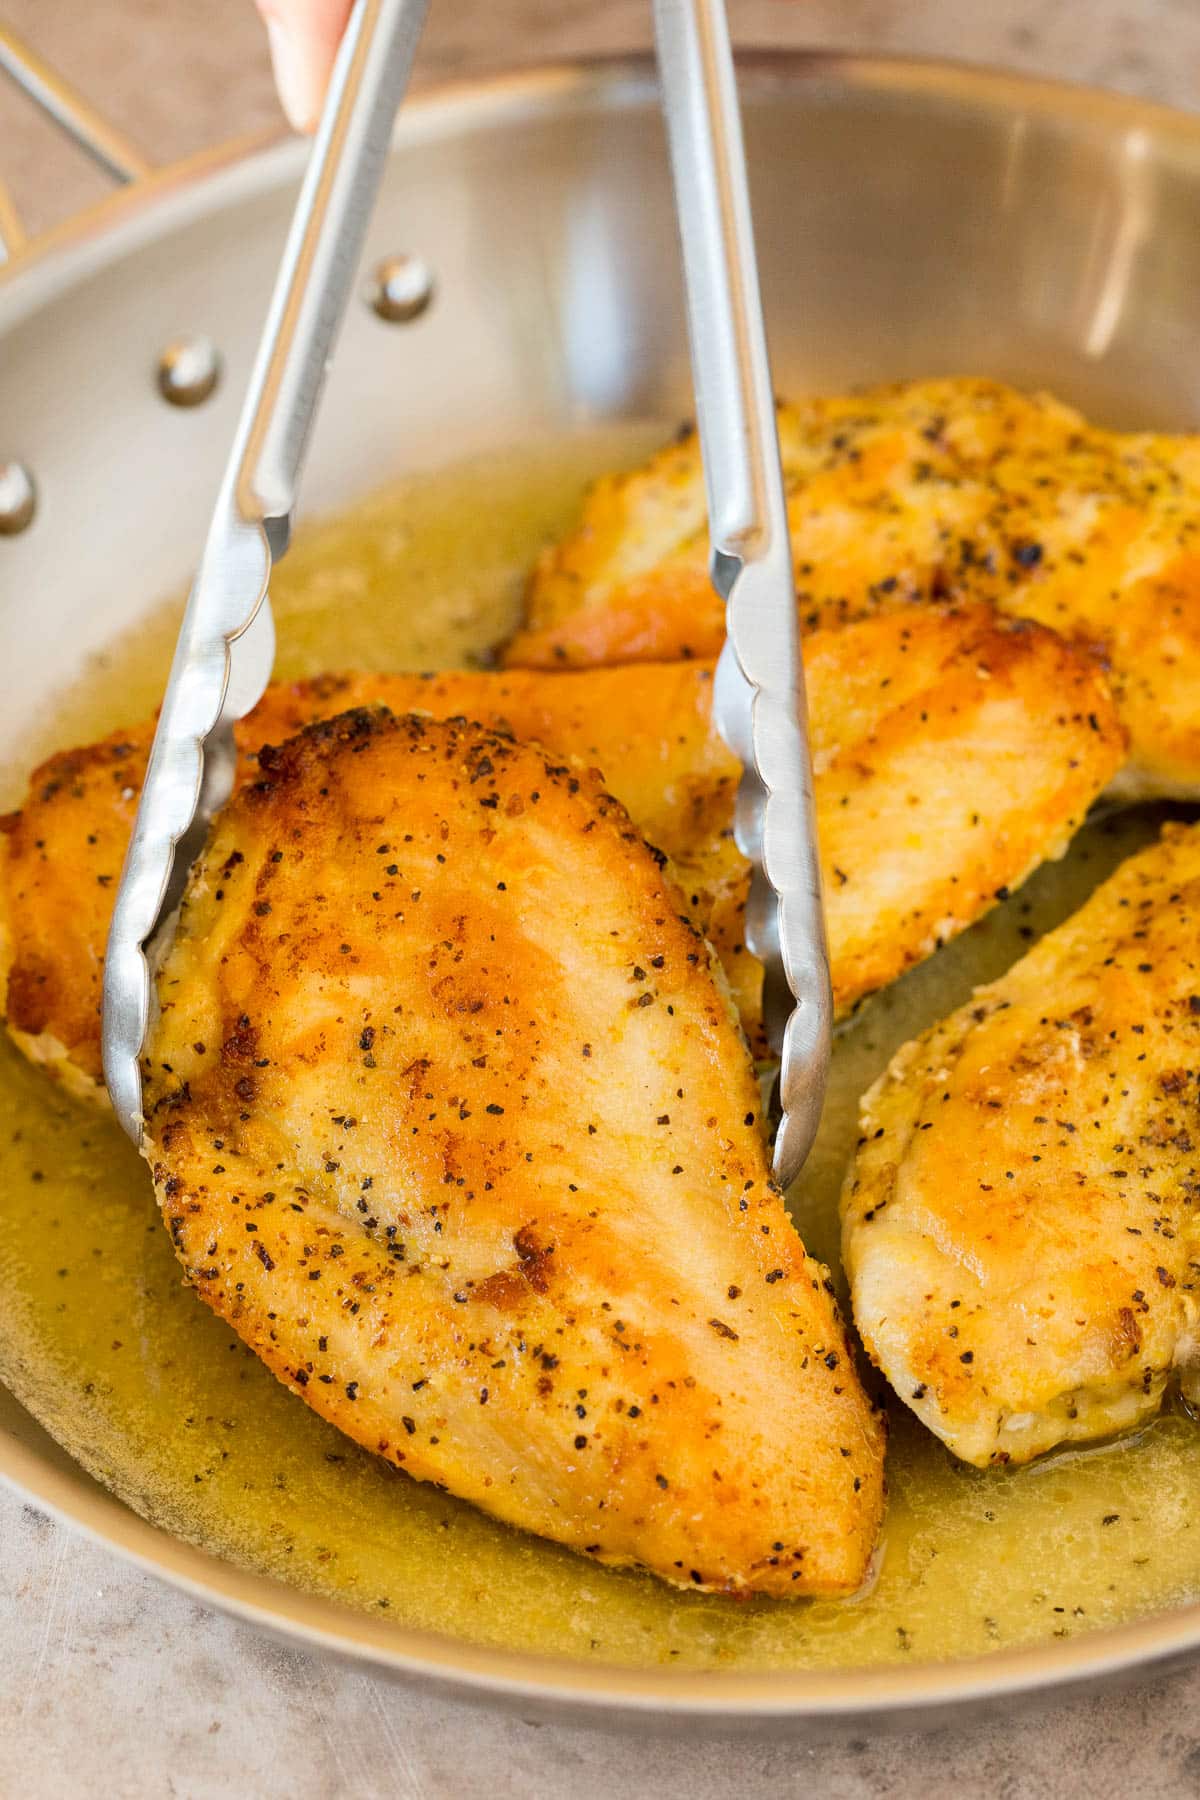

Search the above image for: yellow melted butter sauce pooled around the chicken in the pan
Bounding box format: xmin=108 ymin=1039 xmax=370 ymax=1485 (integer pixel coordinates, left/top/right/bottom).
xmin=0 ymin=430 xmax=1200 ymax=1669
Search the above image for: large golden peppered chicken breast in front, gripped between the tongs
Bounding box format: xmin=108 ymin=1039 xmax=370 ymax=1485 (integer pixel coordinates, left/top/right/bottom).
xmin=146 ymin=709 xmax=883 ymax=1595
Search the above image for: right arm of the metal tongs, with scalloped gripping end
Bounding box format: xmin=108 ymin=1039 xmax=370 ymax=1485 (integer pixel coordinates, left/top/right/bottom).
xmin=655 ymin=0 xmax=833 ymax=1186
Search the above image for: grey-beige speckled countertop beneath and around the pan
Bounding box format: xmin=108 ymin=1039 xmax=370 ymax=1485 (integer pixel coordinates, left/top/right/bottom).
xmin=0 ymin=0 xmax=1200 ymax=1800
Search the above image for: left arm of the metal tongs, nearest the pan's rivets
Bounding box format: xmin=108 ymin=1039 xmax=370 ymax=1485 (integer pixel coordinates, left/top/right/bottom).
xmin=103 ymin=0 xmax=426 ymax=1143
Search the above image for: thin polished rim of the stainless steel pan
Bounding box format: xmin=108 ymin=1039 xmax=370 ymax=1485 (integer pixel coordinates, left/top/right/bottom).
xmin=0 ymin=49 xmax=1200 ymax=1728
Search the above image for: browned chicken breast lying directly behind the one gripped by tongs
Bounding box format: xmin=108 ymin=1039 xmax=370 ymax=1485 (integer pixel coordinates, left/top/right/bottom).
xmin=0 ymin=608 xmax=1123 ymax=1094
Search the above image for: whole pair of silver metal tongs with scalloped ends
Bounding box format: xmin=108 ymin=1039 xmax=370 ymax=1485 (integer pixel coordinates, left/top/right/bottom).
xmin=103 ymin=0 xmax=831 ymax=1184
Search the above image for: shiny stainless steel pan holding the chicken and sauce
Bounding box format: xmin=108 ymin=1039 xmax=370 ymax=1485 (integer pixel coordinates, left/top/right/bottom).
xmin=0 ymin=45 xmax=1200 ymax=1730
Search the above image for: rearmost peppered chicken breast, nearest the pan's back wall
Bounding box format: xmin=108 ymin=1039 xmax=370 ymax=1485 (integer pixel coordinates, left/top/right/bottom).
xmin=506 ymin=380 xmax=1200 ymax=797
